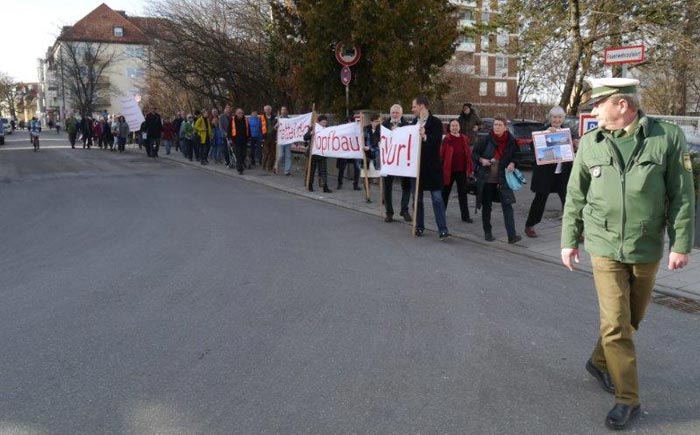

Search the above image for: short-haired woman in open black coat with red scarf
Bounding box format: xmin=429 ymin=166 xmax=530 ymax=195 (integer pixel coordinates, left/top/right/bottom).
xmin=472 ymin=116 xmax=522 ymax=244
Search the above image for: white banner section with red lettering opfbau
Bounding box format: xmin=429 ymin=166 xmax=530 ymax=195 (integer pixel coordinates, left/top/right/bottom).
xmin=312 ymin=122 xmax=362 ymax=159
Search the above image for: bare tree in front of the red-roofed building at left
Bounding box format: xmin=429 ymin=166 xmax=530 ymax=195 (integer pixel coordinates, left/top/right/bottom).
xmin=57 ymin=39 xmax=117 ymax=115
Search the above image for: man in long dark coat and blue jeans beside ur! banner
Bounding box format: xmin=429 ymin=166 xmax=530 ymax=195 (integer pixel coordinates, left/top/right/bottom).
xmin=411 ymin=96 xmax=450 ymax=240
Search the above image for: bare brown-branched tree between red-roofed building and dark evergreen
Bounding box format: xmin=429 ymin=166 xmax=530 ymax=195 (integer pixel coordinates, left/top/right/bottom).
xmin=147 ymin=0 xmax=272 ymax=108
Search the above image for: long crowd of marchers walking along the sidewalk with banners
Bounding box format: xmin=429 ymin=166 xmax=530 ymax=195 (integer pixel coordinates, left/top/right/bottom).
xmin=47 ymin=97 xmax=571 ymax=243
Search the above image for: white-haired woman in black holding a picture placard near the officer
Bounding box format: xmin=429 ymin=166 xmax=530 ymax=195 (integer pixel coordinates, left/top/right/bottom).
xmin=525 ymin=106 xmax=573 ymax=237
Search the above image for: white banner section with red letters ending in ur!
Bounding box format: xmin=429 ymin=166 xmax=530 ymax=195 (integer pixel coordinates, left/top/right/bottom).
xmin=379 ymin=125 xmax=420 ymax=178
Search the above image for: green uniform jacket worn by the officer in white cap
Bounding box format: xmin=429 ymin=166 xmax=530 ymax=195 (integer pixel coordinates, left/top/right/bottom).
xmin=561 ymin=111 xmax=695 ymax=263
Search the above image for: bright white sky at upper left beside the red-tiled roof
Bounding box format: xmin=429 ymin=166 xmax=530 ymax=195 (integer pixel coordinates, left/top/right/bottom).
xmin=0 ymin=0 xmax=147 ymax=82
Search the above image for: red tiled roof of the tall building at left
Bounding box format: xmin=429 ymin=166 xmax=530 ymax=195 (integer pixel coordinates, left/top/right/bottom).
xmin=58 ymin=3 xmax=149 ymax=44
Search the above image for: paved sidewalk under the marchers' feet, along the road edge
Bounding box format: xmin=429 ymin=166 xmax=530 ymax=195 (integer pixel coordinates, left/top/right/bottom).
xmin=160 ymin=151 xmax=700 ymax=300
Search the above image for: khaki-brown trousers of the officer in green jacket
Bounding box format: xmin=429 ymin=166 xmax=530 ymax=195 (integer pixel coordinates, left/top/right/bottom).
xmin=591 ymin=256 xmax=660 ymax=405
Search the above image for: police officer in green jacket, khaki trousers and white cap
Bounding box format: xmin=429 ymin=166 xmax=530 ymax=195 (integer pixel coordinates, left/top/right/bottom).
xmin=561 ymin=78 xmax=695 ymax=430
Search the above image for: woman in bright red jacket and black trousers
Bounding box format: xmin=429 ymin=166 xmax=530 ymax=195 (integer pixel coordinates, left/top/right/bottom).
xmin=440 ymin=119 xmax=473 ymax=223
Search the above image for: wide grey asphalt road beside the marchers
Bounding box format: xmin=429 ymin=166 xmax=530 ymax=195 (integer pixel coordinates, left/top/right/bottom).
xmin=0 ymin=132 xmax=700 ymax=435
